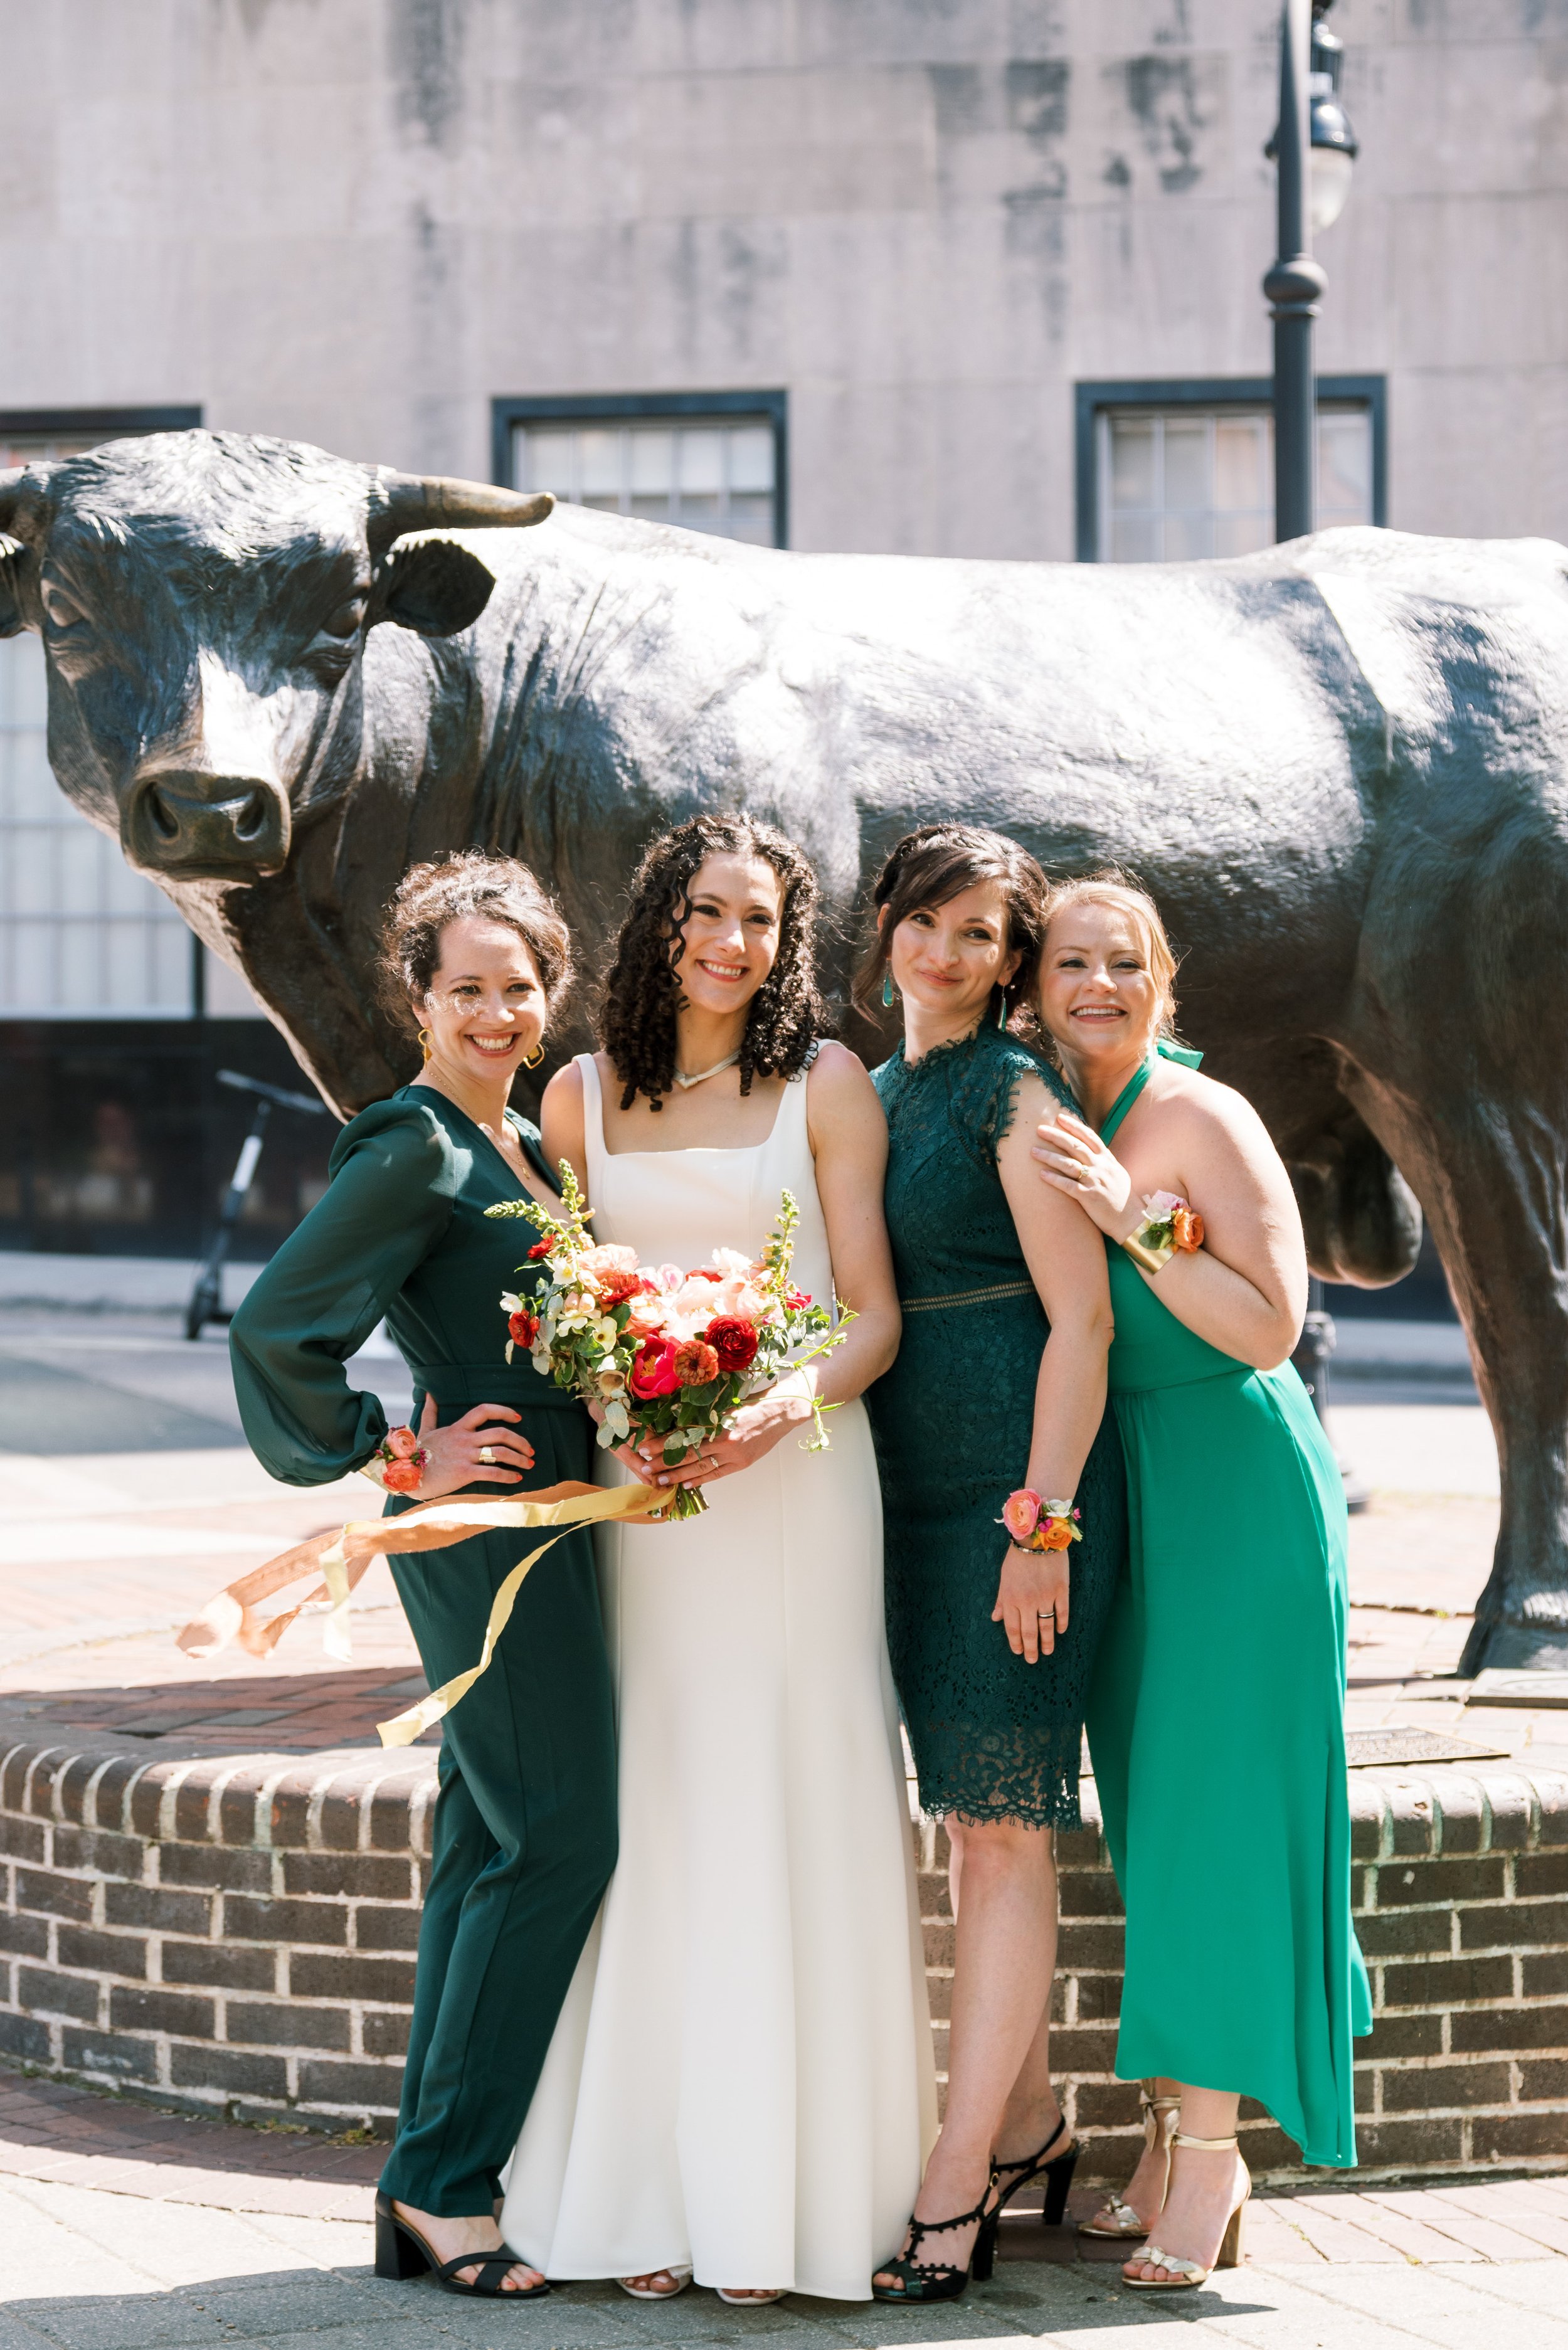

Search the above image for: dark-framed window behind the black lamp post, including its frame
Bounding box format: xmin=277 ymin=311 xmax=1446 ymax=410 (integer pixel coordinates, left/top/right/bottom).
xmin=1077 ymin=376 xmax=1387 ymax=564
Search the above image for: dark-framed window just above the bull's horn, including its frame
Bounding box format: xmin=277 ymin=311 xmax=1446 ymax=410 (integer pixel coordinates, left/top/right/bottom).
xmin=494 ymin=393 xmax=788 ymax=548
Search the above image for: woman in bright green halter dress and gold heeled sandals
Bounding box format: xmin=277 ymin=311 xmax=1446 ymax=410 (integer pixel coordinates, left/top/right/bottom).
xmin=1034 ymin=881 xmax=1370 ymax=2289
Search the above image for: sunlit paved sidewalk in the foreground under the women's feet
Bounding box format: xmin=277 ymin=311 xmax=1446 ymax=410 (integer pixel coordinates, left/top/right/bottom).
xmin=0 ymin=2073 xmax=1568 ymax=2350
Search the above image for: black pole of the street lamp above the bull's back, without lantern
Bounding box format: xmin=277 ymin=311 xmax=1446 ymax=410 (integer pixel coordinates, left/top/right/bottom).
xmin=1263 ymin=0 xmax=1328 ymax=538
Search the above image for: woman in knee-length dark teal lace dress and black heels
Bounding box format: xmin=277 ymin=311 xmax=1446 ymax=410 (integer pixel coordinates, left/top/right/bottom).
xmin=861 ymin=825 xmax=1126 ymax=2300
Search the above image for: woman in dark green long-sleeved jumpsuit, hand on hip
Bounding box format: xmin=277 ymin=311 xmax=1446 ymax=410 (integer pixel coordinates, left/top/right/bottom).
xmin=230 ymin=853 xmax=616 ymax=2291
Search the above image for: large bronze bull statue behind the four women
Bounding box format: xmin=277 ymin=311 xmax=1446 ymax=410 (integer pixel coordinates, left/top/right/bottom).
xmin=0 ymin=432 xmax=1568 ymax=1668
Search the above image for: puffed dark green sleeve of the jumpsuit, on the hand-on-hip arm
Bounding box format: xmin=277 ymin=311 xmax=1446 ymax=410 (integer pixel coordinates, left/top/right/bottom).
xmin=228 ymin=1102 xmax=458 ymax=1485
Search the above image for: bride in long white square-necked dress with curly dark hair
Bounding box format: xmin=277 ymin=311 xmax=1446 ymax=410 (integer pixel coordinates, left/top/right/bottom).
xmin=503 ymin=818 xmax=936 ymax=2303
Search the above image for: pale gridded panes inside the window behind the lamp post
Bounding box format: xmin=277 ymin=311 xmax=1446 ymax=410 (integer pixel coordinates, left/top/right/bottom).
xmin=1096 ymin=406 xmax=1373 ymax=564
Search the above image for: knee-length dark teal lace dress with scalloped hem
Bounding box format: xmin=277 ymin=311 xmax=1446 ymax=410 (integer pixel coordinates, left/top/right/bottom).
xmin=865 ymin=1025 xmax=1126 ymax=1828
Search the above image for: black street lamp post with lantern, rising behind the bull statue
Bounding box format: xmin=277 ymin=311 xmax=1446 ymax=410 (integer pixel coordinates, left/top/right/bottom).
xmin=1263 ymin=0 xmax=1364 ymax=1509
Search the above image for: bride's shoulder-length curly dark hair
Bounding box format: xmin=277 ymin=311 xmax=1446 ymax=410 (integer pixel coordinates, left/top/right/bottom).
xmin=600 ymin=815 xmax=827 ymax=1109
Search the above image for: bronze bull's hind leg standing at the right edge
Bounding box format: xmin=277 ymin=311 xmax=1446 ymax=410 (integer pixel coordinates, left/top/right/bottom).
xmin=1345 ymin=1069 xmax=1568 ymax=1673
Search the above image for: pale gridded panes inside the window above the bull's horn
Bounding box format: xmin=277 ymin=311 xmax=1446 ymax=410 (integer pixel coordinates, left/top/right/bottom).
xmin=512 ymin=416 xmax=776 ymax=548
